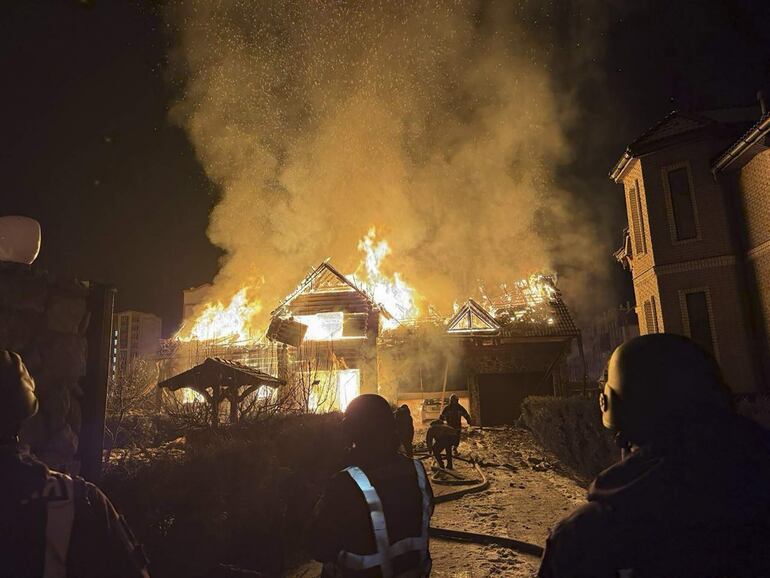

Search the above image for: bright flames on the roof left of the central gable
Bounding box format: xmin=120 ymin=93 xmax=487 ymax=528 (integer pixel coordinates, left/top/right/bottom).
xmin=177 ymin=287 xmax=262 ymax=341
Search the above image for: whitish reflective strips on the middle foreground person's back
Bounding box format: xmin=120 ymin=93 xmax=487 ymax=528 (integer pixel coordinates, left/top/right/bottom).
xmin=337 ymin=460 xmax=430 ymax=578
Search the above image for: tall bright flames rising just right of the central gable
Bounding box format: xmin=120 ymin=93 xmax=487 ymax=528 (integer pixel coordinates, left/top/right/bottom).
xmin=347 ymin=227 xmax=420 ymax=330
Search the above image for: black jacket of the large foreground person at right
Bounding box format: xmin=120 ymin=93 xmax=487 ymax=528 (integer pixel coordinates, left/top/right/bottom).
xmin=538 ymin=416 xmax=770 ymax=578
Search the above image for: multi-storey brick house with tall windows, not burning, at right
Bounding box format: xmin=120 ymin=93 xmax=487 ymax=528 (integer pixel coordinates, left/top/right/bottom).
xmin=610 ymin=98 xmax=770 ymax=393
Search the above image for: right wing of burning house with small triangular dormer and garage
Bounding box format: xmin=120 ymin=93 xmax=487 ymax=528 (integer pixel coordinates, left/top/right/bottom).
xmin=380 ymin=276 xmax=579 ymax=425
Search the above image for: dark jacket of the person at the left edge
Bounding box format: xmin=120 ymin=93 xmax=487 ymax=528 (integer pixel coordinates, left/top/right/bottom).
xmin=0 ymin=446 xmax=148 ymax=578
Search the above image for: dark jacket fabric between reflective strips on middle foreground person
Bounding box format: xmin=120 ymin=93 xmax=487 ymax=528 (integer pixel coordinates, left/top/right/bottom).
xmin=310 ymin=451 xmax=433 ymax=578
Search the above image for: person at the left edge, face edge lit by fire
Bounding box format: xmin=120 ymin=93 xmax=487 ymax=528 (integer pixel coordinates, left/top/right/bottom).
xmin=0 ymin=350 xmax=149 ymax=578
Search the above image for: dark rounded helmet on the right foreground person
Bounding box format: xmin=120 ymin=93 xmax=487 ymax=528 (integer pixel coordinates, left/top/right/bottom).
xmin=599 ymin=333 xmax=731 ymax=443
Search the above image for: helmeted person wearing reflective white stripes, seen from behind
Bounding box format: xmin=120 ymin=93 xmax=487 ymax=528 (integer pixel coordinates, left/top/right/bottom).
xmin=310 ymin=394 xmax=433 ymax=577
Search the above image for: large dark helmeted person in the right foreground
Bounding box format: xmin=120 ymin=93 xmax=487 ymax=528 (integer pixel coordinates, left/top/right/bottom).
xmin=539 ymin=334 xmax=770 ymax=578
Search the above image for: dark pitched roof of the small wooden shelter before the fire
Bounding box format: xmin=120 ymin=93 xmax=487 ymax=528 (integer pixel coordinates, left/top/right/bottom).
xmin=158 ymin=357 xmax=286 ymax=391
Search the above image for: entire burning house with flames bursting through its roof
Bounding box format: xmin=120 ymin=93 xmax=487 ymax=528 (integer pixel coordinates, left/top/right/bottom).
xmin=167 ymin=230 xmax=579 ymax=425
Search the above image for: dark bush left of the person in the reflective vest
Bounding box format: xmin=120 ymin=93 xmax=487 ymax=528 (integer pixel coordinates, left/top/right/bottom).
xmin=103 ymin=414 xmax=344 ymax=578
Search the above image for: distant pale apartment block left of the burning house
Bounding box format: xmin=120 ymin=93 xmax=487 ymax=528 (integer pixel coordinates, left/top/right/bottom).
xmin=111 ymin=311 xmax=161 ymax=378
